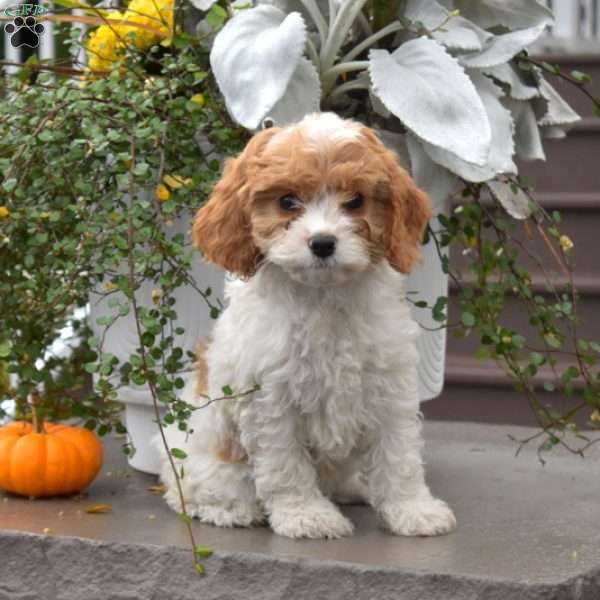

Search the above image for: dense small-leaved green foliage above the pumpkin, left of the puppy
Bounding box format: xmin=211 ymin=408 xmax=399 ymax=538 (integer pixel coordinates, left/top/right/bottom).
xmin=0 ymin=39 xmax=245 ymax=434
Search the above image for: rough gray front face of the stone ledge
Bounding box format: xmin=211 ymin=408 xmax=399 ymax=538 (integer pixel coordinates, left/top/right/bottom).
xmin=0 ymin=531 xmax=600 ymax=600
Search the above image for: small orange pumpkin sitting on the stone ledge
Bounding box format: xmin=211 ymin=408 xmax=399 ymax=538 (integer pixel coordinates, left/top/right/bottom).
xmin=0 ymin=421 xmax=102 ymax=498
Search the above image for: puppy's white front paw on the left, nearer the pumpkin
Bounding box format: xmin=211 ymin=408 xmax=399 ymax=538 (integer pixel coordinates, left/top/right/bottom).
xmin=270 ymin=498 xmax=354 ymax=538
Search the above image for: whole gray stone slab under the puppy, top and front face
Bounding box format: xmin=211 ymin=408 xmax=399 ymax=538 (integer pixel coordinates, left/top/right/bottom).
xmin=0 ymin=423 xmax=600 ymax=600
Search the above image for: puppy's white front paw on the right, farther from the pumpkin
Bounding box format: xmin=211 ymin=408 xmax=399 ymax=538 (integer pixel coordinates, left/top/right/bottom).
xmin=379 ymin=498 xmax=456 ymax=536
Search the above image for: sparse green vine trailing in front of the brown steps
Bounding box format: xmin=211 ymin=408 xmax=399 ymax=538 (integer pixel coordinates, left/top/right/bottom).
xmin=430 ymin=180 xmax=600 ymax=460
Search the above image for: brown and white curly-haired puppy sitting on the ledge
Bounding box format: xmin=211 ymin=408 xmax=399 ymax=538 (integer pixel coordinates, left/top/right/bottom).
xmin=161 ymin=113 xmax=456 ymax=538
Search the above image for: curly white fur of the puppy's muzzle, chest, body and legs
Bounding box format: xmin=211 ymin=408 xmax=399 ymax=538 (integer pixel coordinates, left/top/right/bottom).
xmin=155 ymin=112 xmax=455 ymax=538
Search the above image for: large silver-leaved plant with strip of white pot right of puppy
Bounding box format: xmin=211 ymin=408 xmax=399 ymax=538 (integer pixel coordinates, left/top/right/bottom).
xmin=205 ymin=0 xmax=578 ymax=400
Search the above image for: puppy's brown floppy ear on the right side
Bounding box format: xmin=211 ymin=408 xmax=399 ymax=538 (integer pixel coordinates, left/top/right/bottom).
xmin=387 ymin=165 xmax=433 ymax=273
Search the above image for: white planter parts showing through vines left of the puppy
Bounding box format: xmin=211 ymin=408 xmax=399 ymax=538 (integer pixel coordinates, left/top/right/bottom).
xmin=90 ymin=216 xmax=224 ymax=473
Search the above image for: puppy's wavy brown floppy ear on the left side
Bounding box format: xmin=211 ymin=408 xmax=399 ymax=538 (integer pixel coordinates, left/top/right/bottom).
xmin=192 ymin=127 xmax=280 ymax=277
